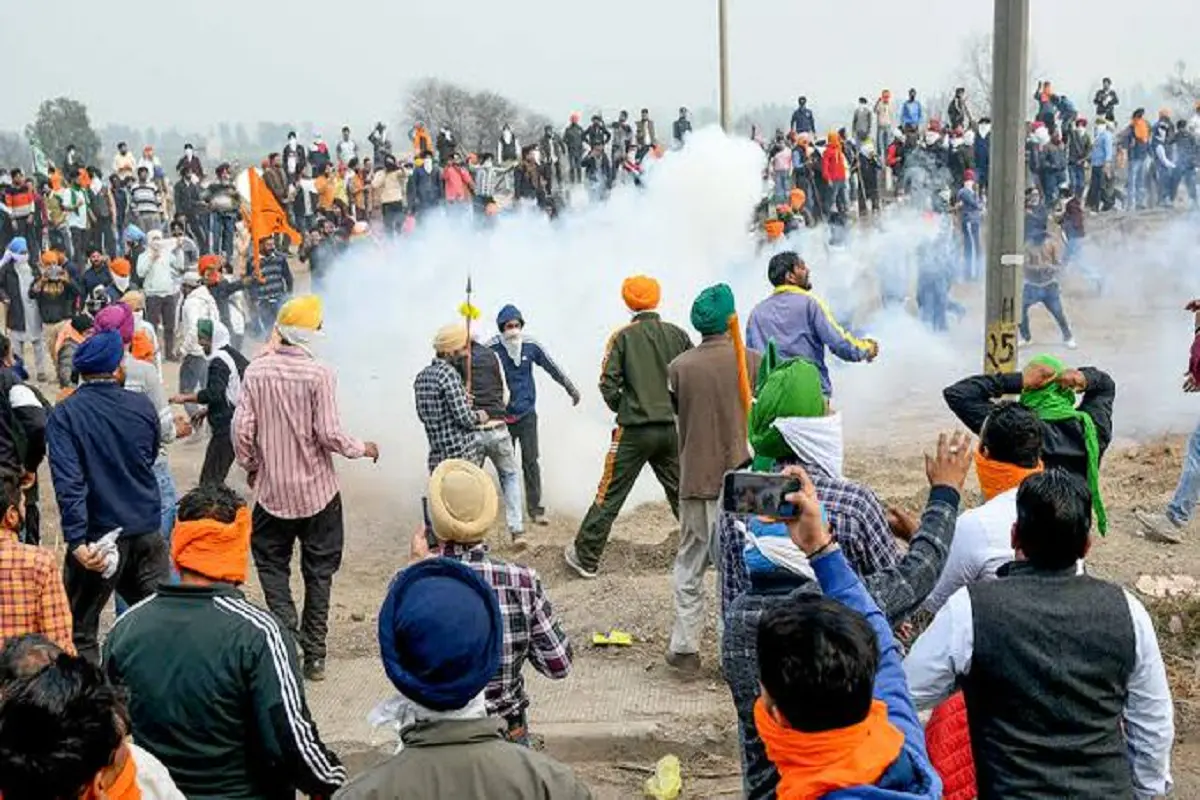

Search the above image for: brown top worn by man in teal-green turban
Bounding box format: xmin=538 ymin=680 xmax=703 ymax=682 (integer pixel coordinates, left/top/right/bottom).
xmin=667 ymin=333 xmax=760 ymax=500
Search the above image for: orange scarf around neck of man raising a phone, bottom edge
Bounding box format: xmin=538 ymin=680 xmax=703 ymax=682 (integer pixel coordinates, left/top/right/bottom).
xmin=754 ymin=697 xmax=904 ymax=800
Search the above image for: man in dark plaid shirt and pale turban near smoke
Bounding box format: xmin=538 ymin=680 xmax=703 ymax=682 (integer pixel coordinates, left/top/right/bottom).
xmin=413 ymin=323 xmax=487 ymax=473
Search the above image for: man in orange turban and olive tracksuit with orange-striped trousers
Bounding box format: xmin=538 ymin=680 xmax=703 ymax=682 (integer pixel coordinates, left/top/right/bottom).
xmin=564 ymin=275 xmax=691 ymax=578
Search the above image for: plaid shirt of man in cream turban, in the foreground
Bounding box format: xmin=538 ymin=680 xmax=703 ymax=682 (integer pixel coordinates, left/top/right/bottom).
xmin=442 ymin=542 xmax=571 ymax=722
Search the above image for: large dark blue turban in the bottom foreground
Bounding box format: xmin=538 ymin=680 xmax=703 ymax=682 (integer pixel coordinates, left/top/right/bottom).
xmin=379 ymin=558 xmax=504 ymax=711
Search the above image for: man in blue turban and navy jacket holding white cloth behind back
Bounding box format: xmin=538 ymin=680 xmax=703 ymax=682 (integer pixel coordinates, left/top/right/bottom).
xmin=46 ymin=331 xmax=169 ymax=663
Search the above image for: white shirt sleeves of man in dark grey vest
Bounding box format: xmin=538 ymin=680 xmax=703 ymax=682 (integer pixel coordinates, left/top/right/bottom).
xmin=904 ymin=578 xmax=1175 ymax=800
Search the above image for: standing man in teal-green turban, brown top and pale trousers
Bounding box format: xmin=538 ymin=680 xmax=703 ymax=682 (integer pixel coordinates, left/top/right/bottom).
xmin=666 ymin=283 xmax=760 ymax=672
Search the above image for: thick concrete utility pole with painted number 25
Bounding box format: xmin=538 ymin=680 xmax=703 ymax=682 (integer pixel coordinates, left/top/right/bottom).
xmin=983 ymin=0 xmax=1030 ymax=373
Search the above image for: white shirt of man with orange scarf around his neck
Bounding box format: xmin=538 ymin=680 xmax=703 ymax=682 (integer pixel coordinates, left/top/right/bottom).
xmin=922 ymin=488 xmax=1016 ymax=614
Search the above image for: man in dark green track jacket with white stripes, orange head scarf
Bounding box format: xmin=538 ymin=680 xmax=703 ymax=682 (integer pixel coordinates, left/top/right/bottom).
xmin=104 ymin=485 xmax=346 ymax=800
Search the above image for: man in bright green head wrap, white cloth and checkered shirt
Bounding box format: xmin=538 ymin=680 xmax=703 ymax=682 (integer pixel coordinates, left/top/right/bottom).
xmin=716 ymin=343 xmax=916 ymax=609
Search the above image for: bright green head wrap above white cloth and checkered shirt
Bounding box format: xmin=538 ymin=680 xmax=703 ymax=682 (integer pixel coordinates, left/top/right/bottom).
xmin=749 ymin=342 xmax=826 ymax=473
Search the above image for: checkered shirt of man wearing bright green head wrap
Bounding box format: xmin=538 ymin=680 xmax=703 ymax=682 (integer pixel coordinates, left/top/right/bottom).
xmin=716 ymin=470 xmax=900 ymax=613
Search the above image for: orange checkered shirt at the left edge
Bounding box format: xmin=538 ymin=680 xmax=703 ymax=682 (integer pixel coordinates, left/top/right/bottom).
xmin=0 ymin=533 xmax=74 ymax=654
